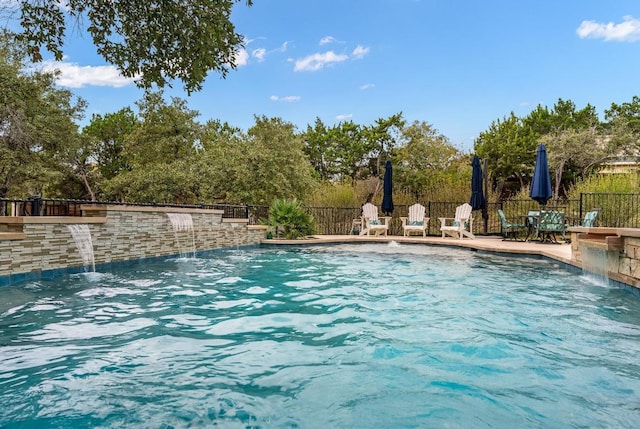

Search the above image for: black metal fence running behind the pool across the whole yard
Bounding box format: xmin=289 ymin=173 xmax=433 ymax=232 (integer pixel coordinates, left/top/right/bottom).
xmin=0 ymin=193 xmax=640 ymax=235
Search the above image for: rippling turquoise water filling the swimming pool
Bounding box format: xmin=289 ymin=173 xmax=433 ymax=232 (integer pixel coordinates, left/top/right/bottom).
xmin=0 ymin=245 xmax=640 ymax=429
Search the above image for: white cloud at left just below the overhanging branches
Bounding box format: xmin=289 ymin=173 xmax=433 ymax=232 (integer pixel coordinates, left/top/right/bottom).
xmin=42 ymin=61 xmax=134 ymax=88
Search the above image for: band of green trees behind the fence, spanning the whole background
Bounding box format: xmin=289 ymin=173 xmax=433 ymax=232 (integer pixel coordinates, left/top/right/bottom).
xmin=0 ymin=21 xmax=640 ymax=206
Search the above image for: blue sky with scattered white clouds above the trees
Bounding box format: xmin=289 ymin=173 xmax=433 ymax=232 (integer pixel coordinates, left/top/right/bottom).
xmin=7 ymin=0 xmax=640 ymax=151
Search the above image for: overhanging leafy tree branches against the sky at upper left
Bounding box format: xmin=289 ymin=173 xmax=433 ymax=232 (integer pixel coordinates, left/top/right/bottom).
xmin=13 ymin=0 xmax=252 ymax=92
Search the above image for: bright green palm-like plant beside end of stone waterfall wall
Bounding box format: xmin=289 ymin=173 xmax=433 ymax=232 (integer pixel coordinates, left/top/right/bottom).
xmin=267 ymin=198 xmax=314 ymax=239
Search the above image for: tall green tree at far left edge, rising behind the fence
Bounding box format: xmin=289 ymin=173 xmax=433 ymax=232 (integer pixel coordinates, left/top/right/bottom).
xmin=0 ymin=32 xmax=84 ymax=197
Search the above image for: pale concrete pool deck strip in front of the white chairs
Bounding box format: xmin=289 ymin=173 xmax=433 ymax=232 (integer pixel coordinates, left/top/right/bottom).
xmin=261 ymin=235 xmax=581 ymax=268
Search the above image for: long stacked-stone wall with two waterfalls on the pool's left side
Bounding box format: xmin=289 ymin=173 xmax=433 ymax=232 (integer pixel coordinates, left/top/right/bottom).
xmin=0 ymin=205 xmax=265 ymax=285
